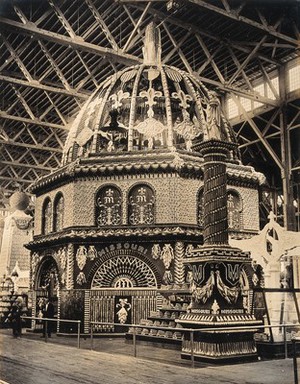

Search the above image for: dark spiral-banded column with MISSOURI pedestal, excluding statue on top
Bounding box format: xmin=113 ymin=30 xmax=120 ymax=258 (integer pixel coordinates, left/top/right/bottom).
xmin=177 ymin=139 xmax=260 ymax=363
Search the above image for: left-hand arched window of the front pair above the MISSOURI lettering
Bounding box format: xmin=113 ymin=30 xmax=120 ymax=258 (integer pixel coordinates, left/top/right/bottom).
xmin=96 ymin=185 xmax=122 ymax=226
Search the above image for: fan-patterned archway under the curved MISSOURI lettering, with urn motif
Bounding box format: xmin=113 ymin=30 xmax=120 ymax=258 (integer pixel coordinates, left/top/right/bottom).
xmin=85 ymin=254 xmax=158 ymax=332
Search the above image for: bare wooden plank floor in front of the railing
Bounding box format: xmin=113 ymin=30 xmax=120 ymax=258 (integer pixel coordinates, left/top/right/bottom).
xmin=0 ymin=330 xmax=300 ymax=384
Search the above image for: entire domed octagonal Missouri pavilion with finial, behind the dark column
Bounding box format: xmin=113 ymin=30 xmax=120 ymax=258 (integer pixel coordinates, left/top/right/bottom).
xmin=28 ymin=23 xmax=263 ymax=339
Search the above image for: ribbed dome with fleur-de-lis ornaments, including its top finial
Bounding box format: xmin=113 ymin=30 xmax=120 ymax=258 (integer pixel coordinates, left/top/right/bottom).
xmin=63 ymin=23 xmax=234 ymax=164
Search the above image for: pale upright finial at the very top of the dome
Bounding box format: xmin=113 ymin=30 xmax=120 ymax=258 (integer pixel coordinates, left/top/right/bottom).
xmin=143 ymin=21 xmax=161 ymax=65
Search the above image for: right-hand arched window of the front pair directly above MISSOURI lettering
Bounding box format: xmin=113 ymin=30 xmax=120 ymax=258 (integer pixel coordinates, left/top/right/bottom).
xmin=128 ymin=184 xmax=155 ymax=225
